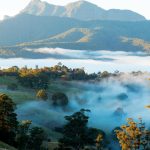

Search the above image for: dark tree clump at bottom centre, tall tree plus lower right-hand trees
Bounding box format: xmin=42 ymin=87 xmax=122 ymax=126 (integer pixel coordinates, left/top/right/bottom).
xmin=57 ymin=109 xmax=105 ymax=150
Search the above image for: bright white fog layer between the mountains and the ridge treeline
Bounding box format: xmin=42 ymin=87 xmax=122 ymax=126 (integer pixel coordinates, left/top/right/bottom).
xmin=0 ymin=48 xmax=150 ymax=73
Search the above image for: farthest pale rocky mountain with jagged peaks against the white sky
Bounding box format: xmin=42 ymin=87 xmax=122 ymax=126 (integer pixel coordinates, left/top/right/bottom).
xmin=21 ymin=0 xmax=145 ymax=21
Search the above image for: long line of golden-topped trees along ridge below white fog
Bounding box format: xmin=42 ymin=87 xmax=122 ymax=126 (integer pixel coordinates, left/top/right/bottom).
xmin=0 ymin=63 xmax=119 ymax=89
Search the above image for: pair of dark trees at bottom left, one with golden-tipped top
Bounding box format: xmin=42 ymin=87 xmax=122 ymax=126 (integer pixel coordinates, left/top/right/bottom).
xmin=16 ymin=120 xmax=47 ymax=150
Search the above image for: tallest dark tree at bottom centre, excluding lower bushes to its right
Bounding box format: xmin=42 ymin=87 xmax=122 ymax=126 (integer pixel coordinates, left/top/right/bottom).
xmin=60 ymin=109 xmax=89 ymax=150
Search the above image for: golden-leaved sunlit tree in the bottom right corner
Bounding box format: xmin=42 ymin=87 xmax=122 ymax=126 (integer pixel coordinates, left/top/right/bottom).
xmin=116 ymin=118 xmax=150 ymax=150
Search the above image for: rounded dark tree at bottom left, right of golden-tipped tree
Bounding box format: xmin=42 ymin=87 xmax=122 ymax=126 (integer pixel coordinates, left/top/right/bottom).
xmin=29 ymin=127 xmax=46 ymax=150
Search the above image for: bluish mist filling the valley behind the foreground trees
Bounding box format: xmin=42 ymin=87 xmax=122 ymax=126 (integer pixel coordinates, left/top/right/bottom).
xmin=17 ymin=74 xmax=150 ymax=131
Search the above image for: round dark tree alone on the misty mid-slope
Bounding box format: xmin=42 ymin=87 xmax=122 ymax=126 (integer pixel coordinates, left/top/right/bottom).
xmin=52 ymin=92 xmax=68 ymax=106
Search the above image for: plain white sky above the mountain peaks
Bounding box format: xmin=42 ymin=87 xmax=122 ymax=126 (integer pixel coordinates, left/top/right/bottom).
xmin=0 ymin=0 xmax=150 ymax=19
